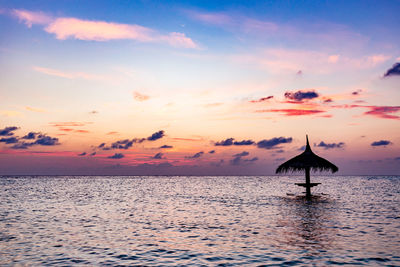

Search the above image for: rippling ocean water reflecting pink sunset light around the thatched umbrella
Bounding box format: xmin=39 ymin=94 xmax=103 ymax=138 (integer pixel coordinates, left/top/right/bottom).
xmin=0 ymin=176 xmax=400 ymax=266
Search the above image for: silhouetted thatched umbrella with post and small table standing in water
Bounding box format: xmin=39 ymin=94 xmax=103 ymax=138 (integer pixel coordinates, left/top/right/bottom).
xmin=276 ymin=135 xmax=339 ymax=197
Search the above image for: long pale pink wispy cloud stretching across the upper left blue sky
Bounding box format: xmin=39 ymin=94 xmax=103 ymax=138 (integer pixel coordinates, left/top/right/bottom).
xmin=13 ymin=9 xmax=198 ymax=48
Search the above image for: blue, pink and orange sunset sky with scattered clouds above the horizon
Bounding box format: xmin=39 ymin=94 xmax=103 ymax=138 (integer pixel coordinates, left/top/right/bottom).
xmin=0 ymin=0 xmax=400 ymax=175
